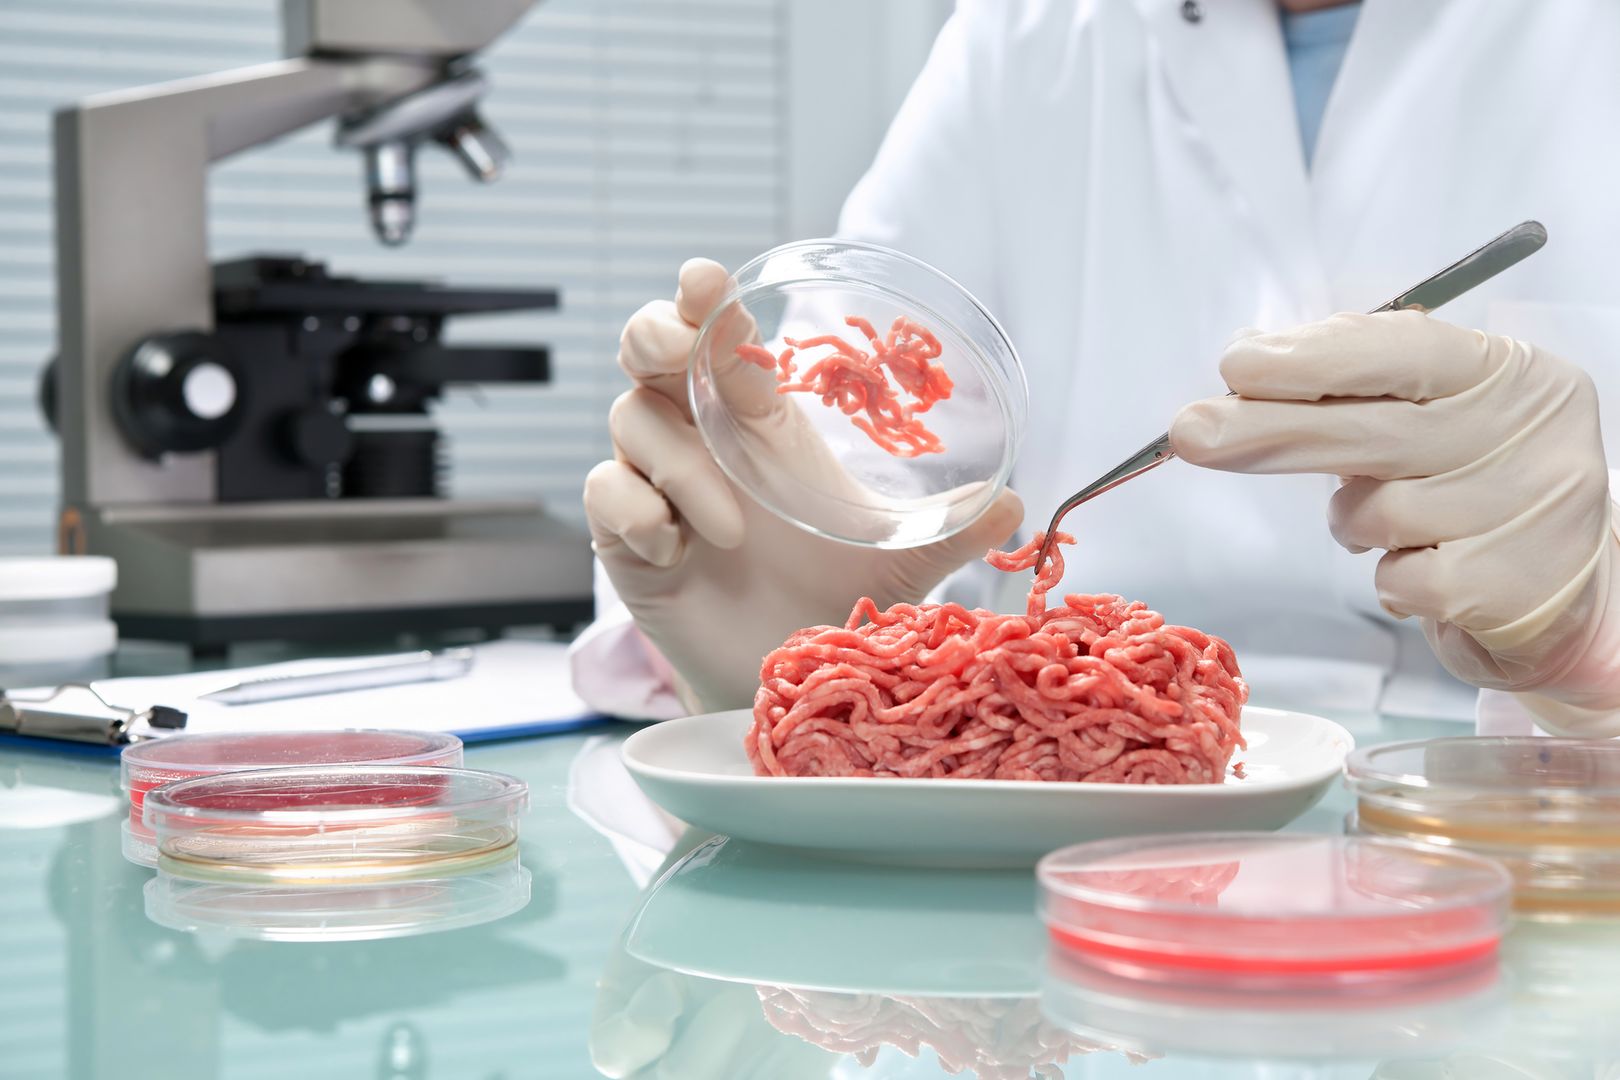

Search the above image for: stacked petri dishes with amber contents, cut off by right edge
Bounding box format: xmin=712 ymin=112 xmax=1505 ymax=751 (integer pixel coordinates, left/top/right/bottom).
xmin=1345 ymin=735 xmax=1620 ymax=920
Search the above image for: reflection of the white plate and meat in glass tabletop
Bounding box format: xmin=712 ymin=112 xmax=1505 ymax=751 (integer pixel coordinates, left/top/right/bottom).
xmin=591 ymin=839 xmax=1140 ymax=1080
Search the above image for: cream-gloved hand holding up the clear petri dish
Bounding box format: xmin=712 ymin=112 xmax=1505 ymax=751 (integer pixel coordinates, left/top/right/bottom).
xmin=585 ymin=259 xmax=1024 ymax=711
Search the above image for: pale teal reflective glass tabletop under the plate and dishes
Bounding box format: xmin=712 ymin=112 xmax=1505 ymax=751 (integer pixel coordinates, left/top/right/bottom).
xmin=0 ymin=648 xmax=1620 ymax=1080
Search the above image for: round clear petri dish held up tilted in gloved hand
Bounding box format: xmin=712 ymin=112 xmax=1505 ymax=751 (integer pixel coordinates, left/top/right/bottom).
xmin=689 ymin=240 xmax=1029 ymax=547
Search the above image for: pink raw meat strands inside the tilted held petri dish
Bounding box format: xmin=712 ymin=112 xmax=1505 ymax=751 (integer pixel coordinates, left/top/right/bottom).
xmin=737 ymin=316 xmax=953 ymax=458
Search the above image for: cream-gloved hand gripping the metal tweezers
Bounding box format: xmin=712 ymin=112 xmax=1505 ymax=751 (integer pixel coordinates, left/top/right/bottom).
xmin=1170 ymin=311 xmax=1620 ymax=735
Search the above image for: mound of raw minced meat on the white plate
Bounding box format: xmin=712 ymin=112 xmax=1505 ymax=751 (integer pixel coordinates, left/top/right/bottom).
xmin=745 ymin=534 xmax=1249 ymax=784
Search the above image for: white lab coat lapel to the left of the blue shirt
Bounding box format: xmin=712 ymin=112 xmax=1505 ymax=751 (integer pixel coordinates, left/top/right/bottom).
xmin=1136 ymin=0 xmax=1327 ymax=317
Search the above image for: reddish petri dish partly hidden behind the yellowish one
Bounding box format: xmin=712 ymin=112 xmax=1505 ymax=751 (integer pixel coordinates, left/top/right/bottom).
xmin=118 ymin=729 xmax=462 ymax=866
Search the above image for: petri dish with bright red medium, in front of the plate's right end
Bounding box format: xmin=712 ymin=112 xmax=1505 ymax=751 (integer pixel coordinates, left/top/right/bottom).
xmin=1035 ymin=832 xmax=1510 ymax=984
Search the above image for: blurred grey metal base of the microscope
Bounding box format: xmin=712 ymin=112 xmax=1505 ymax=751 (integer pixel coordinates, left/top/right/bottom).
xmin=83 ymin=499 xmax=591 ymax=649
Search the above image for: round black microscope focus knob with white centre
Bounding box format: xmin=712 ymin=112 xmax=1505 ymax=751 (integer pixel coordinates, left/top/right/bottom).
xmin=112 ymin=330 xmax=245 ymax=458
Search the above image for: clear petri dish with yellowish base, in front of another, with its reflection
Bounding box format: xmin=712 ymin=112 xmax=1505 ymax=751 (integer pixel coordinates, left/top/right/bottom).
xmin=141 ymin=764 xmax=530 ymax=941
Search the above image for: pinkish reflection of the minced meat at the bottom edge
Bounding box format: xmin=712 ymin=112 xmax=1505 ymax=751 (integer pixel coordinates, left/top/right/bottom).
xmin=755 ymin=986 xmax=1145 ymax=1080
